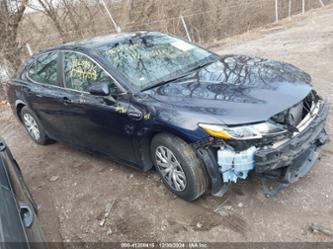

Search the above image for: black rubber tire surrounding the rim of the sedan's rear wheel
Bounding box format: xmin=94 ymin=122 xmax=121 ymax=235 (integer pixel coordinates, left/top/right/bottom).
xmin=20 ymin=106 xmax=50 ymax=145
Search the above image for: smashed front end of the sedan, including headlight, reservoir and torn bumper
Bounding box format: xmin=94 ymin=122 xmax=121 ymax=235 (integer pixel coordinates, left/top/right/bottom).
xmin=194 ymin=91 xmax=329 ymax=197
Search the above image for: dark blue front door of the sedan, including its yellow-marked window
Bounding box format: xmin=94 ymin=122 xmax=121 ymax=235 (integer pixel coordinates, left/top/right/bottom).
xmin=59 ymin=52 xmax=136 ymax=162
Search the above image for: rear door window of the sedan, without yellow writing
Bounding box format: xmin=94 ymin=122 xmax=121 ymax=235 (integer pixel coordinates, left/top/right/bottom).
xmin=28 ymin=52 xmax=58 ymax=85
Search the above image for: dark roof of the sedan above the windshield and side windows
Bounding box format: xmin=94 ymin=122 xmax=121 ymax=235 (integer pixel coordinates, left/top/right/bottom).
xmin=41 ymin=31 xmax=162 ymax=52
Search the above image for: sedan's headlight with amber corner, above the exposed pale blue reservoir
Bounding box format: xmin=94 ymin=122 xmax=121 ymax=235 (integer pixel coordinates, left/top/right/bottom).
xmin=199 ymin=122 xmax=286 ymax=140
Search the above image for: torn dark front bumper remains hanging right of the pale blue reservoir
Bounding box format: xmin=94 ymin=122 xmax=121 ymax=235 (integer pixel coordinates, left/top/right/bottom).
xmin=255 ymin=98 xmax=329 ymax=197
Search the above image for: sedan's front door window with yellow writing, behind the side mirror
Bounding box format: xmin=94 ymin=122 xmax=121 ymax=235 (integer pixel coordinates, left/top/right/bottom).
xmin=64 ymin=52 xmax=118 ymax=94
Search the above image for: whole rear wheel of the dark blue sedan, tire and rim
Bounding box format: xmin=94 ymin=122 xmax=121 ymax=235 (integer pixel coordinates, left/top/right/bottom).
xmin=20 ymin=106 xmax=49 ymax=145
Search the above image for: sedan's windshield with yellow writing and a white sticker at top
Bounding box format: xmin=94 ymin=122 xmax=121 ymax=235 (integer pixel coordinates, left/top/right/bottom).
xmin=98 ymin=34 xmax=218 ymax=90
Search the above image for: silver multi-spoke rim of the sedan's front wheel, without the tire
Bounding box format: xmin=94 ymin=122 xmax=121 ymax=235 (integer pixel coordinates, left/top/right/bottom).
xmin=155 ymin=146 xmax=187 ymax=192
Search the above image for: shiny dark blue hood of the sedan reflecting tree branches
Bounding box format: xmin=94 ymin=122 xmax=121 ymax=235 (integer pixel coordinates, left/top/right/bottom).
xmin=147 ymin=55 xmax=312 ymax=125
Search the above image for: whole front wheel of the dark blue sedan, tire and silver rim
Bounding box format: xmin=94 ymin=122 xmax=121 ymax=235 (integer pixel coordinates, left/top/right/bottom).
xmin=151 ymin=134 xmax=208 ymax=201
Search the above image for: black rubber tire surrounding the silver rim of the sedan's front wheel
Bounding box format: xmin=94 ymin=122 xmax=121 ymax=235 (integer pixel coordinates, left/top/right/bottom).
xmin=151 ymin=133 xmax=209 ymax=201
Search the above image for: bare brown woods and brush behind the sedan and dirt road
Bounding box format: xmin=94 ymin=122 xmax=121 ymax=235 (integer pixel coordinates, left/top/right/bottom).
xmin=0 ymin=0 xmax=333 ymax=99
